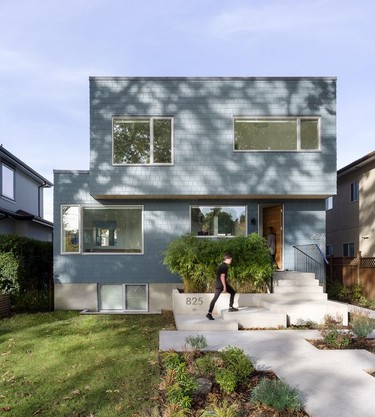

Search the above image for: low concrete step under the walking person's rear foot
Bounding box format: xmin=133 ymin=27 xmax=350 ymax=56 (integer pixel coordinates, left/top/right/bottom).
xmin=174 ymin=312 xmax=238 ymax=331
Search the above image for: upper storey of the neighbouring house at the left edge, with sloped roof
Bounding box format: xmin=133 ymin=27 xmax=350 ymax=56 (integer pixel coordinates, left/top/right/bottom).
xmin=0 ymin=145 xmax=53 ymax=227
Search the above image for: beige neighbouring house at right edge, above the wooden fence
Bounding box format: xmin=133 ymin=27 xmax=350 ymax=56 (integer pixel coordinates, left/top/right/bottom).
xmin=326 ymin=152 xmax=375 ymax=257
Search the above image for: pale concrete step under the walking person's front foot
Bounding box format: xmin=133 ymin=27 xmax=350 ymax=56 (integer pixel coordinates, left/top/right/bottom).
xmin=221 ymin=307 xmax=287 ymax=329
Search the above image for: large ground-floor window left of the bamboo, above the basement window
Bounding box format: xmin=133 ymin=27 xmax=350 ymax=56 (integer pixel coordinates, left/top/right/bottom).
xmin=62 ymin=206 xmax=143 ymax=253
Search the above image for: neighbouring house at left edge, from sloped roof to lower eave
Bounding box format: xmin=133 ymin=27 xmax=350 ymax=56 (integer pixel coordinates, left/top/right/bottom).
xmin=0 ymin=145 xmax=53 ymax=242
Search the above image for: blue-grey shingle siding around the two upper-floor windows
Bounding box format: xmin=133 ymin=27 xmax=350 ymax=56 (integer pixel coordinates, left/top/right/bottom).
xmin=90 ymin=77 xmax=336 ymax=196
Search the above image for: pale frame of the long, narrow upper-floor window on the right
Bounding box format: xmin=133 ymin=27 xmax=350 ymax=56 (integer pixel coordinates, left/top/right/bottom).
xmin=233 ymin=115 xmax=321 ymax=152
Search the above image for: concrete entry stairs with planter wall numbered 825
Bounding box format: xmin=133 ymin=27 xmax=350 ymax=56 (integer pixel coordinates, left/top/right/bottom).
xmin=173 ymin=271 xmax=348 ymax=331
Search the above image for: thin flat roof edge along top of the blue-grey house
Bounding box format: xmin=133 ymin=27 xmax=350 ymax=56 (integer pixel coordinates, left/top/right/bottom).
xmin=89 ymin=76 xmax=337 ymax=81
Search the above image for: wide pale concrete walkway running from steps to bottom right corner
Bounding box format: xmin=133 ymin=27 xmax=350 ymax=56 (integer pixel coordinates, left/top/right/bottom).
xmin=159 ymin=330 xmax=375 ymax=417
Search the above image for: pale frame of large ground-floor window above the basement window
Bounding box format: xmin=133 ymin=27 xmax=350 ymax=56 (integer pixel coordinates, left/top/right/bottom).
xmin=60 ymin=204 xmax=145 ymax=256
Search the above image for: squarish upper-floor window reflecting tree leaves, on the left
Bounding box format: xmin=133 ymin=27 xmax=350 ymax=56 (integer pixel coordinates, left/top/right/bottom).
xmin=113 ymin=117 xmax=173 ymax=165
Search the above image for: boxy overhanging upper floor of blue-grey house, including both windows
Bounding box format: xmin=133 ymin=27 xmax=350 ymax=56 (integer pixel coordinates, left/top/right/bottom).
xmin=89 ymin=77 xmax=337 ymax=199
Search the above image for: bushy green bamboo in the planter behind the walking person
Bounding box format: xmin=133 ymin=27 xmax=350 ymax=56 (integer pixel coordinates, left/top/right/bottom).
xmin=163 ymin=233 xmax=274 ymax=292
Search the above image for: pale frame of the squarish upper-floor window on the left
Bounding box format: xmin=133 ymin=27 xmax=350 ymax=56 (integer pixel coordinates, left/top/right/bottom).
xmin=112 ymin=115 xmax=174 ymax=166
